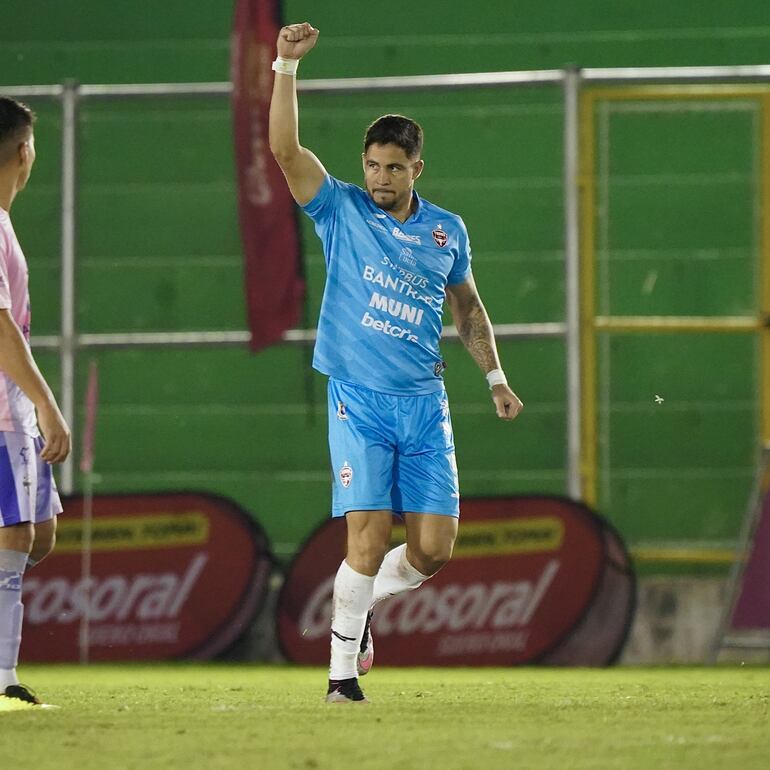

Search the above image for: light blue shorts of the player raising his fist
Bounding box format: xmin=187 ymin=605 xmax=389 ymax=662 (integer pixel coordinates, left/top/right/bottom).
xmin=329 ymin=379 xmax=460 ymax=517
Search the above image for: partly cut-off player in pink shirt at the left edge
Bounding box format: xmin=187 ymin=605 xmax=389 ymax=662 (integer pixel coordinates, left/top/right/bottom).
xmin=0 ymin=97 xmax=70 ymax=709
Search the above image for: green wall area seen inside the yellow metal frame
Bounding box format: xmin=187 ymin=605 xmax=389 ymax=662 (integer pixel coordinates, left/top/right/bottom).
xmin=594 ymin=94 xmax=762 ymax=543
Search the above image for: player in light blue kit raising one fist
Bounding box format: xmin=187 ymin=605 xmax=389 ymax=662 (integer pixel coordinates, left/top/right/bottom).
xmin=270 ymin=23 xmax=522 ymax=703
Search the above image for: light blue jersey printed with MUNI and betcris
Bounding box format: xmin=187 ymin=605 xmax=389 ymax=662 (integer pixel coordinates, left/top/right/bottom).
xmin=303 ymin=176 xmax=471 ymax=395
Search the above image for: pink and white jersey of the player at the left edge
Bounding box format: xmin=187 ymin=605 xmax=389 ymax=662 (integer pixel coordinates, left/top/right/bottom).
xmin=0 ymin=208 xmax=39 ymax=436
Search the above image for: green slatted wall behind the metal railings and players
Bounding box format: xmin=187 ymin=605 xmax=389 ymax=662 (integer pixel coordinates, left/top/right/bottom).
xmin=0 ymin=0 xmax=770 ymax=557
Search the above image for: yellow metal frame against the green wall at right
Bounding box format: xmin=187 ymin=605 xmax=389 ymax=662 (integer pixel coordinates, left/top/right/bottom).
xmin=579 ymin=85 xmax=770 ymax=512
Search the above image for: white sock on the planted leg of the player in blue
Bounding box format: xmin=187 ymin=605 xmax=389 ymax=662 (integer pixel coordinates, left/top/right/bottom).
xmin=329 ymin=560 xmax=374 ymax=679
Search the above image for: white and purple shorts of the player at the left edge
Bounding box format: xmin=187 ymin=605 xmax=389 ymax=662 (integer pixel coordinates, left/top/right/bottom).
xmin=0 ymin=431 xmax=62 ymax=527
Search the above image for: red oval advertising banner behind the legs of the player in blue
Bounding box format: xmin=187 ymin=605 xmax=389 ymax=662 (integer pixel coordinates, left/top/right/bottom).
xmin=277 ymin=496 xmax=634 ymax=666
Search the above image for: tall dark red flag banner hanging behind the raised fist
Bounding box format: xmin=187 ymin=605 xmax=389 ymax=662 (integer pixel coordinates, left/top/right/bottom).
xmin=231 ymin=0 xmax=305 ymax=350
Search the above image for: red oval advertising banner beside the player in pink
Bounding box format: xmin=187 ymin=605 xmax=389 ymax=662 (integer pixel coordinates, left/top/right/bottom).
xmin=22 ymin=493 xmax=271 ymax=662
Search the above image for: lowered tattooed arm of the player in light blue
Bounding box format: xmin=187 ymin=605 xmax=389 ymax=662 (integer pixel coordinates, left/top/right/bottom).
xmin=447 ymin=276 xmax=524 ymax=420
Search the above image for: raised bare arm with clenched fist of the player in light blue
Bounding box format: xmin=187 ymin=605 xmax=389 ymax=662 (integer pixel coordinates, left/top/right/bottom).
xmin=270 ymin=22 xmax=326 ymax=205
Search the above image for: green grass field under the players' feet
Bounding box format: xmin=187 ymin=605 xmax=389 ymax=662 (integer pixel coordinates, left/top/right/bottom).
xmin=0 ymin=664 xmax=770 ymax=770
